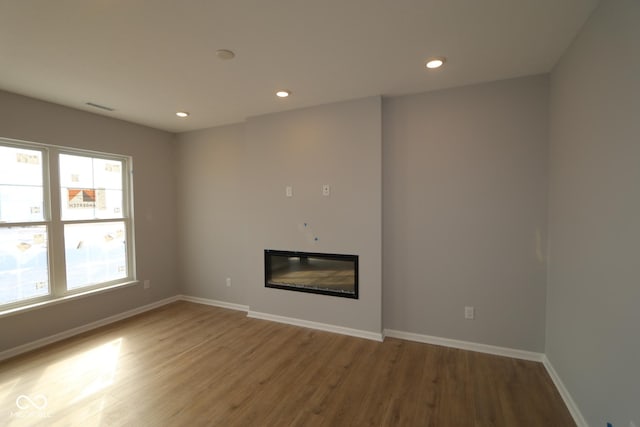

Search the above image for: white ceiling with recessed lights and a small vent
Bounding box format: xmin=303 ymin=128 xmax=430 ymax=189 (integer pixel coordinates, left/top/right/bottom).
xmin=0 ymin=0 xmax=597 ymax=132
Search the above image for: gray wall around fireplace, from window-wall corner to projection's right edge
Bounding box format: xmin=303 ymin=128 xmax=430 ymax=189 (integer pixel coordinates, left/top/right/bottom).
xmin=178 ymin=97 xmax=382 ymax=333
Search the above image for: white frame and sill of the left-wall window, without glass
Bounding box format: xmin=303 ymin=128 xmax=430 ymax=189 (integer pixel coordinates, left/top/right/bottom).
xmin=0 ymin=137 xmax=138 ymax=316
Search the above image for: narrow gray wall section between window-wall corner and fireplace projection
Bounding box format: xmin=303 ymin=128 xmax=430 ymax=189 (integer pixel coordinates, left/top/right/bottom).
xmin=177 ymin=124 xmax=252 ymax=305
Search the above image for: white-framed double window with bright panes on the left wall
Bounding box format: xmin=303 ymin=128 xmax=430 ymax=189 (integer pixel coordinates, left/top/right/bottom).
xmin=0 ymin=139 xmax=135 ymax=311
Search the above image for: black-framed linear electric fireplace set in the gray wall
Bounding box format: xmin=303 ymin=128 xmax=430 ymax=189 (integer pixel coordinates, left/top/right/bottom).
xmin=264 ymin=249 xmax=358 ymax=299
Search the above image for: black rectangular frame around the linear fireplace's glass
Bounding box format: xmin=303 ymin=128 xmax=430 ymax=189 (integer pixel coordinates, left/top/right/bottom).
xmin=264 ymin=249 xmax=359 ymax=299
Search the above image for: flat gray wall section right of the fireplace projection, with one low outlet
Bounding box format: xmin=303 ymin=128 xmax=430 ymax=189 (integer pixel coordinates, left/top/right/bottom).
xmin=383 ymin=76 xmax=548 ymax=352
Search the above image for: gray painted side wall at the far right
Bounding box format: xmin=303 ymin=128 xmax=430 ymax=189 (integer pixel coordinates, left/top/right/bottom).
xmin=546 ymin=0 xmax=640 ymax=427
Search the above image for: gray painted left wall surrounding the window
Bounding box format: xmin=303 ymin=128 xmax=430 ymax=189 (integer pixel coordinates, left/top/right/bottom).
xmin=0 ymin=91 xmax=178 ymax=351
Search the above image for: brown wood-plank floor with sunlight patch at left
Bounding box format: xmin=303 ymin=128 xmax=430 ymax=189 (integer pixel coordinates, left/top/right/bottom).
xmin=0 ymin=302 xmax=575 ymax=427
